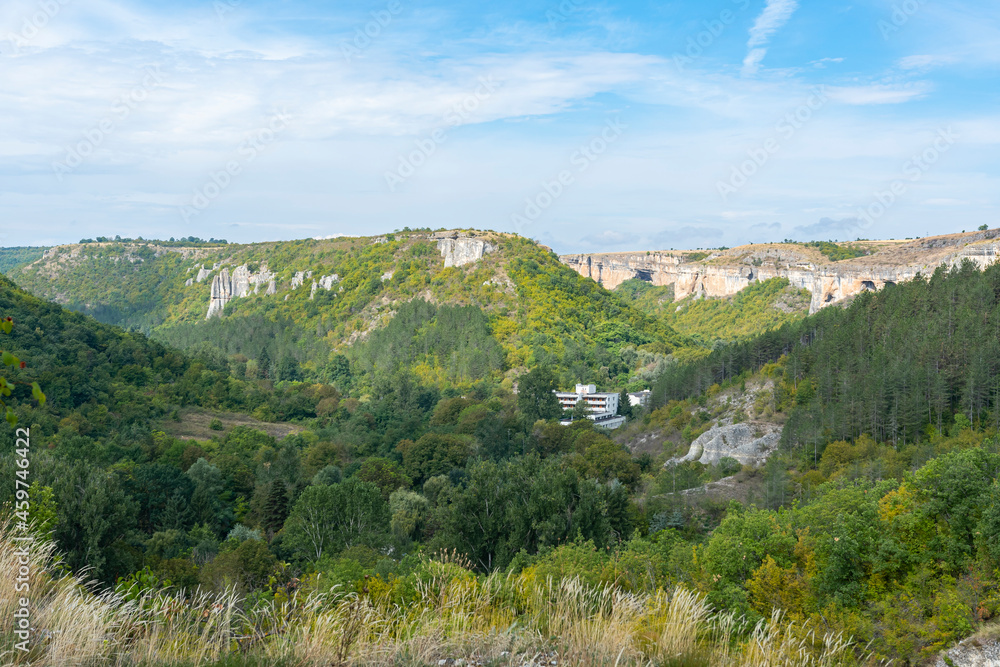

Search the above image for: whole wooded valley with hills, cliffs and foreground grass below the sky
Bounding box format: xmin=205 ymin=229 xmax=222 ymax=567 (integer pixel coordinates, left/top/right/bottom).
xmin=0 ymin=230 xmax=1000 ymax=665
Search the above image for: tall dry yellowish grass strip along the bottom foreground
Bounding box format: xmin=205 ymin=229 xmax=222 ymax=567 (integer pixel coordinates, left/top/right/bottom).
xmin=0 ymin=526 xmax=854 ymax=667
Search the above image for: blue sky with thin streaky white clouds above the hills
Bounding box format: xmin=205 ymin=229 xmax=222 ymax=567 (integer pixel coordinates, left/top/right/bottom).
xmin=0 ymin=0 xmax=1000 ymax=253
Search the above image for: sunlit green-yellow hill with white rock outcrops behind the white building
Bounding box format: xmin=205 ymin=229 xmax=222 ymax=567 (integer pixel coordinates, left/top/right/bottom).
xmin=14 ymin=232 xmax=694 ymax=388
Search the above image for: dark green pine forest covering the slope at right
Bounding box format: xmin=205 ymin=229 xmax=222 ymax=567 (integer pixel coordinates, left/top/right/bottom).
xmin=654 ymin=263 xmax=1000 ymax=446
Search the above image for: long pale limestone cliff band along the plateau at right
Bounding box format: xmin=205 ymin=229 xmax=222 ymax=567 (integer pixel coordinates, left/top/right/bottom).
xmin=560 ymin=230 xmax=1000 ymax=312
